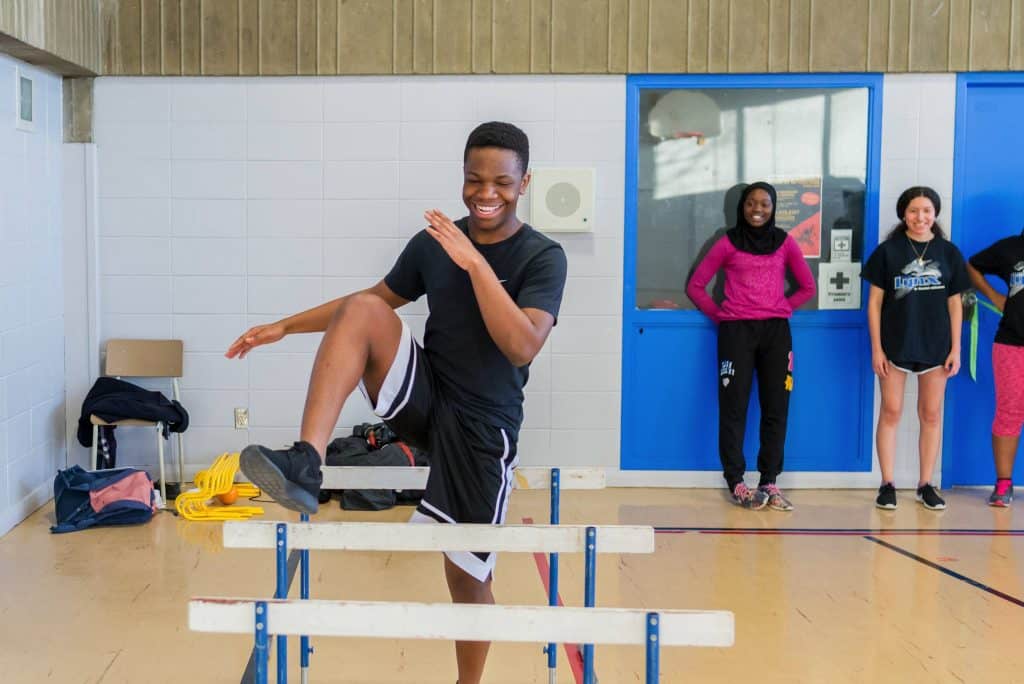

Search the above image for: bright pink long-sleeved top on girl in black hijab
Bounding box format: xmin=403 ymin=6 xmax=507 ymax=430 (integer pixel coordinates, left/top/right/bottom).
xmin=686 ymin=236 xmax=814 ymax=323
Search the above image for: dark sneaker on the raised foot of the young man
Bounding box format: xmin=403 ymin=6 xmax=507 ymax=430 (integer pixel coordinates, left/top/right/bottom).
xmin=240 ymin=441 xmax=324 ymax=515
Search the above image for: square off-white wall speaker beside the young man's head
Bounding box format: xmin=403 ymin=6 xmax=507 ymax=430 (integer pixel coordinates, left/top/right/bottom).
xmin=529 ymin=168 xmax=594 ymax=232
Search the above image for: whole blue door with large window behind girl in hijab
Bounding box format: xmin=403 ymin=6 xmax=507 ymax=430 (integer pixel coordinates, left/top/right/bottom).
xmin=621 ymin=75 xmax=882 ymax=472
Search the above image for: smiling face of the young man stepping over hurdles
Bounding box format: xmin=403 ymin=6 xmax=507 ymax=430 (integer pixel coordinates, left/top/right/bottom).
xmin=462 ymin=147 xmax=529 ymax=243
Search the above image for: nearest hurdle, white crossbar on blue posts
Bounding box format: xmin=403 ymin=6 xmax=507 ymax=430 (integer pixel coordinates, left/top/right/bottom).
xmin=188 ymin=598 xmax=735 ymax=684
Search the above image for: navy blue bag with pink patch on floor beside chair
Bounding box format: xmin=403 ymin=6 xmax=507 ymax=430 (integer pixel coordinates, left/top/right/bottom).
xmin=50 ymin=466 xmax=155 ymax=532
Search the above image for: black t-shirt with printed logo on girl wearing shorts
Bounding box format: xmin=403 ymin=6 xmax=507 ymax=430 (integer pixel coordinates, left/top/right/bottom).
xmin=860 ymin=233 xmax=971 ymax=366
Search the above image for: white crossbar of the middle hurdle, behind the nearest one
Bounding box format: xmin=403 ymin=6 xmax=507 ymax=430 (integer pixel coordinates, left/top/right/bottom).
xmin=223 ymin=520 xmax=654 ymax=553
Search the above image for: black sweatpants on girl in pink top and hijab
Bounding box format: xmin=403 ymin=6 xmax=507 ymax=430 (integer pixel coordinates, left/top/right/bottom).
xmin=718 ymin=318 xmax=793 ymax=491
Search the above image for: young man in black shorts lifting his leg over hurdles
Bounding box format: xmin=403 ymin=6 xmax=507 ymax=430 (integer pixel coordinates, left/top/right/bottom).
xmin=226 ymin=122 xmax=566 ymax=684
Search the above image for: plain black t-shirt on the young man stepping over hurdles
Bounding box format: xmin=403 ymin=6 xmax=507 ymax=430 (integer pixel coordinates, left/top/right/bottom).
xmin=384 ymin=218 xmax=566 ymax=433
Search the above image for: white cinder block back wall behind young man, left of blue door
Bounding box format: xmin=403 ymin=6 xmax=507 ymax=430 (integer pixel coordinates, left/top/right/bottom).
xmin=88 ymin=77 xmax=625 ymax=469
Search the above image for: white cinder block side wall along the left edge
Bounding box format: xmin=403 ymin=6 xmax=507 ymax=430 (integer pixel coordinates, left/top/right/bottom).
xmin=0 ymin=54 xmax=66 ymax=535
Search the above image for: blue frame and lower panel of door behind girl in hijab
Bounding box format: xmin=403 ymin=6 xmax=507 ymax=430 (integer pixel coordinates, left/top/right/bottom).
xmin=620 ymin=74 xmax=883 ymax=472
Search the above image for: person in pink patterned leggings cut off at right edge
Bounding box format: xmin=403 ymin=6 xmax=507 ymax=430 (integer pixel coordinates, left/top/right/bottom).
xmin=968 ymin=234 xmax=1024 ymax=508
